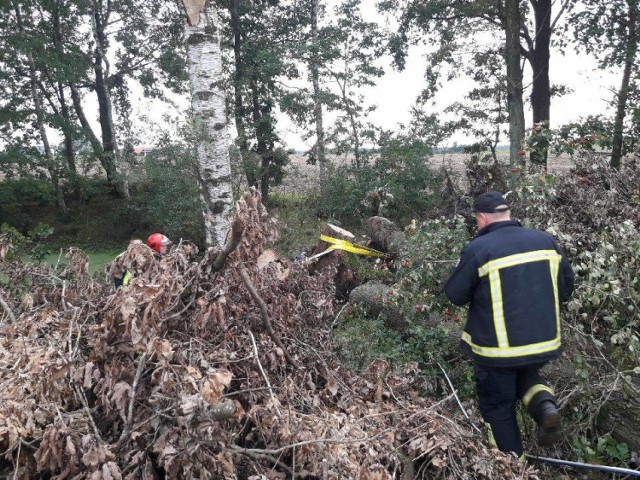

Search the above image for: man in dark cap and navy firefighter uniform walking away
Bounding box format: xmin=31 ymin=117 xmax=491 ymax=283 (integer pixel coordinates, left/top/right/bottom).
xmin=445 ymin=192 xmax=575 ymax=458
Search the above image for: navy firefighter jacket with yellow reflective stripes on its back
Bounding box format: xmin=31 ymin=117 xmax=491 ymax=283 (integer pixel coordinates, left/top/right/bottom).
xmin=445 ymin=220 xmax=574 ymax=367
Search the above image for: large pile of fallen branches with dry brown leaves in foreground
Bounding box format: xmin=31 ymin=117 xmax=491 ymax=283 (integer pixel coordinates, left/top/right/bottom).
xmin=0 ymin=189 xmax=536 ymax=480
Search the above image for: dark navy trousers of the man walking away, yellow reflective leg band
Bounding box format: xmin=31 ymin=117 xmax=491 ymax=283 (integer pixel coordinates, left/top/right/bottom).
xmin=473 ymin=363 xmax=555 ymax=457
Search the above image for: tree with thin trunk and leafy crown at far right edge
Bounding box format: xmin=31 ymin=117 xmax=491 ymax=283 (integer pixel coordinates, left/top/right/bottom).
xmin=573 ymin=0 xmax=640 ymax=168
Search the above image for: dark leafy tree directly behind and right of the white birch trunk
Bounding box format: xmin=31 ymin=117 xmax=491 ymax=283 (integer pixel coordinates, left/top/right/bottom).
xmin=218 ymin=0 xmax=299 ymax=199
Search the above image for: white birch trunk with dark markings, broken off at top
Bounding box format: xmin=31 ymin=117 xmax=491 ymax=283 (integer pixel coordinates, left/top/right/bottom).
xmin=182 ymin=0 xmax=233 ymax=248
